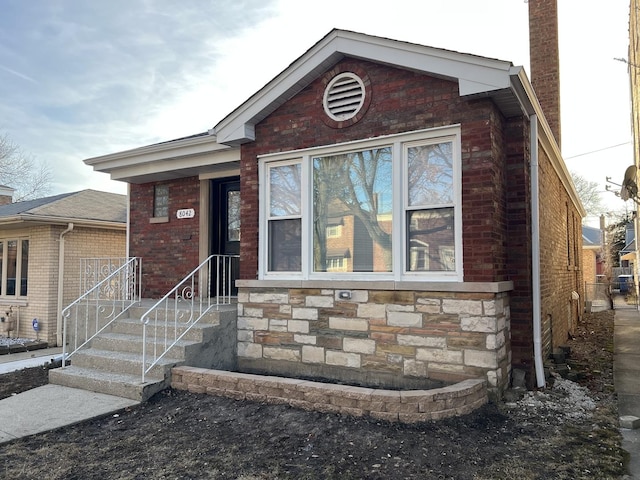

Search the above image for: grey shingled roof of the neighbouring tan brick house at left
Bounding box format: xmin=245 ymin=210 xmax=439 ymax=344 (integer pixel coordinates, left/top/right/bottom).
xmin=0 ymin=190 xmax=127 ymax=229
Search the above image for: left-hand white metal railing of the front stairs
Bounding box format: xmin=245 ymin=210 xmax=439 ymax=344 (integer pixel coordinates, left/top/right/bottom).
xmin=61 ymin=257 xmax=142 ymax=367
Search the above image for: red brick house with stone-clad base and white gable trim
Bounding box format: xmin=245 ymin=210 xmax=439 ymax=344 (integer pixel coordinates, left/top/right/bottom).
xmin=85 ymin=1 xmax=584 ymax=393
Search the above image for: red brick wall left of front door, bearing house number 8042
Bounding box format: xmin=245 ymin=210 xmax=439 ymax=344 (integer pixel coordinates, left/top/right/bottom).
xmin=129 ymin=177 xmax=200 ymax=298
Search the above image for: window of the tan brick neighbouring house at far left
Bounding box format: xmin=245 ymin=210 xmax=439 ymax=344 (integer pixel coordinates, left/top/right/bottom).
xmin=0 ymin=239 xmax=29 ymax=297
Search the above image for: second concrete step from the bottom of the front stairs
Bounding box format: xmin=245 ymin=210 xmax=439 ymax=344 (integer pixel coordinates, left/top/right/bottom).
xmin=70 ymin=348 xmax=184 ymax=378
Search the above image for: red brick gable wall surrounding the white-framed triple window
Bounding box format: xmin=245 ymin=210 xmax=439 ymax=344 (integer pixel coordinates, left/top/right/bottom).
xmin=240 ymin=59 xmax=506 ymax=281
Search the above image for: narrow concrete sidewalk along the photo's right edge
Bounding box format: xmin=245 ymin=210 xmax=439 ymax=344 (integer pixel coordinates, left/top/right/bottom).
xmin=613 ymin=307 xmax=640 ymax=479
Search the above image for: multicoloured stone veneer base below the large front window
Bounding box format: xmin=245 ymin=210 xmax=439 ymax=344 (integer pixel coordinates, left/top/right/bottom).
xmin=238 ymin=280 xmax=512 ymax=396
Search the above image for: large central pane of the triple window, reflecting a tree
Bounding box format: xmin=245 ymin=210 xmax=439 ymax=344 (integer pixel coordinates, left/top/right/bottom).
xmin=313 ymin=147 xmax=393 ymax=272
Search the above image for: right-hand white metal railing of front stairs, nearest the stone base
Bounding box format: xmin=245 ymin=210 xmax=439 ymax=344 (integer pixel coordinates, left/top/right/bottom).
xmin=140 ymin=255 xmax=239 ymax=383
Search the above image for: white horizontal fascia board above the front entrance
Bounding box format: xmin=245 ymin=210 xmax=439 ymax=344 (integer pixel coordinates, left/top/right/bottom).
xmin=84 ymin=135 xmax=229 ymax=173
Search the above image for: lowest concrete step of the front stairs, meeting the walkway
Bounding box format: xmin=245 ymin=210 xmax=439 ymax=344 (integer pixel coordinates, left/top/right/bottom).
xmin=49 ymin=365 xmax=169 ymax=402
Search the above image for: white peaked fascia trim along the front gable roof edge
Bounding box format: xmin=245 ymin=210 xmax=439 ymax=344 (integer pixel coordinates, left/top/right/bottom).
xmin=210 ymin=30 xmax=512 ymax=145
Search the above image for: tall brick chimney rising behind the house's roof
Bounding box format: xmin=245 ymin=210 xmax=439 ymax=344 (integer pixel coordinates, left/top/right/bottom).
xmin=529 ymin=0 xmax=560 ymax=146
